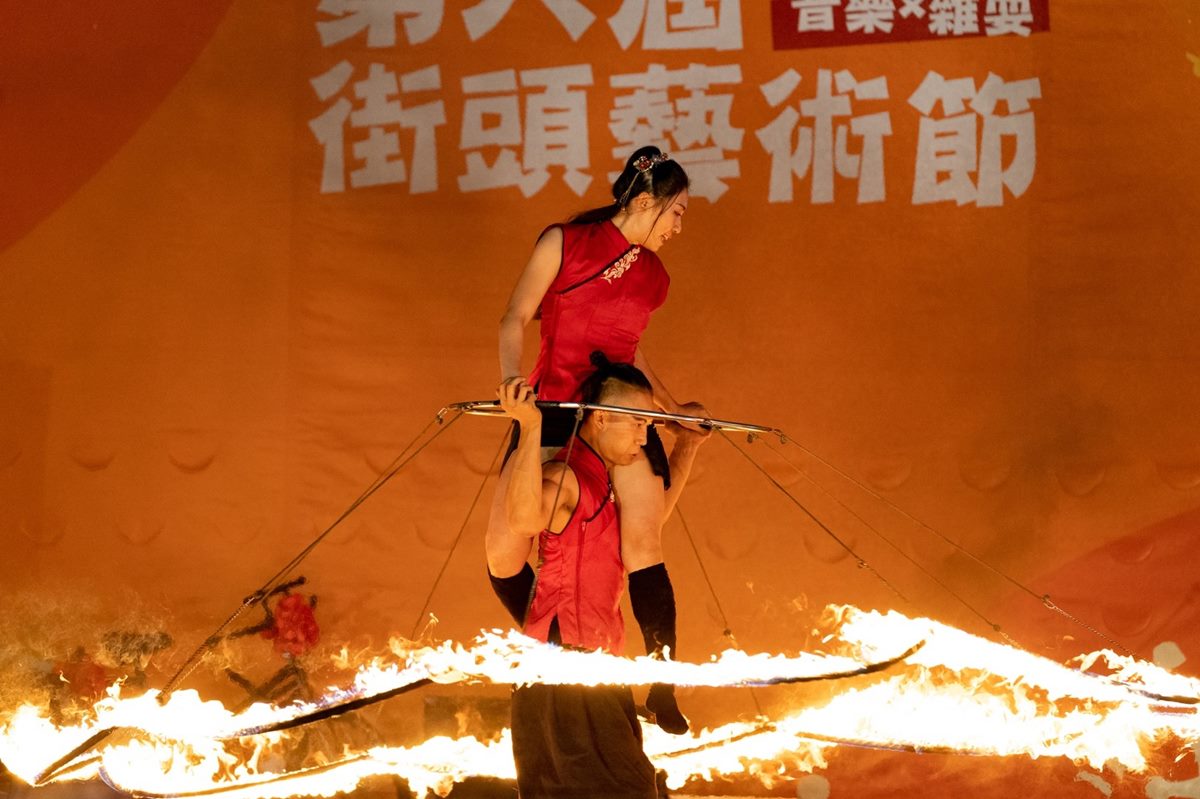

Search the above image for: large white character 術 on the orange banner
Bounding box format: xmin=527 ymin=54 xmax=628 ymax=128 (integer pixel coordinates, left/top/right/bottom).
xmin=755 ymin=70 xmax=892 ymax=204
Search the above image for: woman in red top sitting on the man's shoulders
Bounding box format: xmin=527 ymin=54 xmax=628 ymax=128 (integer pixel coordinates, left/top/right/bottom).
xmin=487 ymin=146 xmax=704 ymax=733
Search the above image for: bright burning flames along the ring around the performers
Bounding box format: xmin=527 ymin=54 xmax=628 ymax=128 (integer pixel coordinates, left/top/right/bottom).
xmin=0 ymin=607 xmax=1200 ymax=799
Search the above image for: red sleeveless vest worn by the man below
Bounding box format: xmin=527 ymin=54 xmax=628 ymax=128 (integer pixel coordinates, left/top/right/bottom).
xmin=524 ymin=438 xmax=625 ymax=655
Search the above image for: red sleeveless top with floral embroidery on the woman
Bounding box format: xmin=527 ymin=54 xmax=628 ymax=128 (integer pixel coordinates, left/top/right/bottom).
xmin=529 ymin=222 xmax=671 ymax=402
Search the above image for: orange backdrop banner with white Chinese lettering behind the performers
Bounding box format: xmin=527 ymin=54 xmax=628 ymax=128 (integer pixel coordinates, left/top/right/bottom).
xmin=0 ymin=0 xmax=1200 ymax=797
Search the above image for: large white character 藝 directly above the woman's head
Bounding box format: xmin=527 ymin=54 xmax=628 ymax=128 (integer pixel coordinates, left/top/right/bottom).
xmin=608 ymin=64 xmax=744 ymax=203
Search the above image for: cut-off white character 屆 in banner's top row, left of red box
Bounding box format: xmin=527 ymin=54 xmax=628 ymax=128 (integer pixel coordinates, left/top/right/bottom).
xmin=608 ymin=0 xmax=742 ymax=50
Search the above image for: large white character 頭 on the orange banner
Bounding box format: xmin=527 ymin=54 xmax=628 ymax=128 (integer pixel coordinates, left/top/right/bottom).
xmin=458 ymin=64 xmax=592 ymax=197
